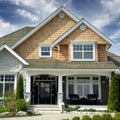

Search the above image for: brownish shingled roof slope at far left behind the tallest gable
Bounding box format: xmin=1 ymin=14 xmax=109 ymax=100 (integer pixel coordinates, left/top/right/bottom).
xmin=0 ymin=27 xmax=34 ymax=47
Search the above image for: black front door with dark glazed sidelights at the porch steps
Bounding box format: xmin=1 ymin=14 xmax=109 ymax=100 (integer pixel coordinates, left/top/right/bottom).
xmin=32 ymin=80 xmax=57 ymax=104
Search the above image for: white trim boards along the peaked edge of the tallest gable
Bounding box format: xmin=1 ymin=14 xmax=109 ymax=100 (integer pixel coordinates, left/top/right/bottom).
xmin=11 ymin=6 xmax=79 ymax=49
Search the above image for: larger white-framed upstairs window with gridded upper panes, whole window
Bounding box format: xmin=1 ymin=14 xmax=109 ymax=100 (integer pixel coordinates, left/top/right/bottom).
xmin=71 ymin=42 xmax=95 ymax=61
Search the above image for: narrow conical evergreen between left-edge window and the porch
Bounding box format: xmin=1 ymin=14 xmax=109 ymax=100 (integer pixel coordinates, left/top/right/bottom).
xmin=16 ymin=74 xmax=24 ymax=100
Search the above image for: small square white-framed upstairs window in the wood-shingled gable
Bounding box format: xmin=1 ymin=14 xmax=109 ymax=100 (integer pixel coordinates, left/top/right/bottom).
xmin=40 ymin=45 xmax=52 ymax=57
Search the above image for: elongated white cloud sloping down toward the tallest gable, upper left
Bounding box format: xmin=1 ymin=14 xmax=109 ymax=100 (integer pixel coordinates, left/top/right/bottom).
xmin=17 ymin=9 xmax=39 ymax=22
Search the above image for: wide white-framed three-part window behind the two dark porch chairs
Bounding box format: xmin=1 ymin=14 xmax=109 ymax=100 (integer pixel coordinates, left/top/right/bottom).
xmin=66 ymin=76 xmax=101 ymax=99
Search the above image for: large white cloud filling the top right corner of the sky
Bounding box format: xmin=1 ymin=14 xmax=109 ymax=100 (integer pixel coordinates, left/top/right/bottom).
xmin=92 ymin=0 xmax=120 ymax=29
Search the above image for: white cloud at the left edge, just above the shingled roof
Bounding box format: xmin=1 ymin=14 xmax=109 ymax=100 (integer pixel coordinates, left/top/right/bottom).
xmin=0 ymin=19 xmax=18 ymax=37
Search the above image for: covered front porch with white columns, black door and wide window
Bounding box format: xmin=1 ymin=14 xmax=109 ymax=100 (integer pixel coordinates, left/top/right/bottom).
xmin=23 ymin=69 xmax=111 ymax=107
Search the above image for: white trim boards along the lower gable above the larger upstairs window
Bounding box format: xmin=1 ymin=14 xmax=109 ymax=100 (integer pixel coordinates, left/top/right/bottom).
xmin=51 ymin=18 xmax=114 ymax=46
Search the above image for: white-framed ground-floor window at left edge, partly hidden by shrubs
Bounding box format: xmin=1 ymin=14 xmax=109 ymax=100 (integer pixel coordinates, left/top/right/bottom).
xmin=0 ymin=75 xmax=15 ymax=97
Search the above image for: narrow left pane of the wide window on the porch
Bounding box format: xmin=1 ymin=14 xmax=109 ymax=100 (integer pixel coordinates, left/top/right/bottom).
xmin=68 ymin=77 xmax=74 ymax=95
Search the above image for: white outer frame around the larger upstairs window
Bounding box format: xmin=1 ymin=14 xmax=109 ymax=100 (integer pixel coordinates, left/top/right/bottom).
xmin=71 ymin=41 xmax=95 ymax=61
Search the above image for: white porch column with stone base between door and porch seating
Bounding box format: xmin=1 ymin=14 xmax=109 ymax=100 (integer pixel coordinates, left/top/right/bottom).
xmin=58 ymin=74 xmax=63 ymax=110
